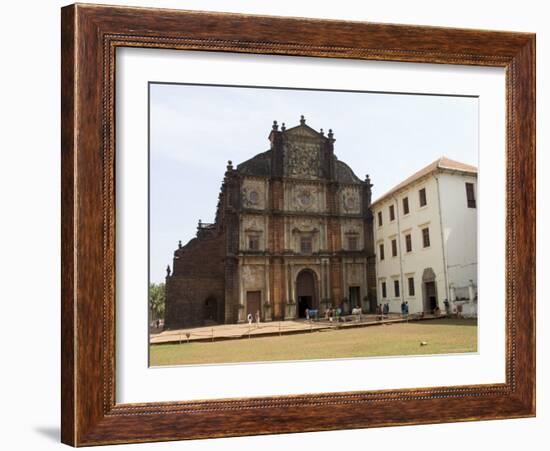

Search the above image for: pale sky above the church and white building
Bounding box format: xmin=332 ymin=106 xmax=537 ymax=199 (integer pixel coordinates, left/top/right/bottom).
xmin=149 ymin=83 xmax=478 ymax=282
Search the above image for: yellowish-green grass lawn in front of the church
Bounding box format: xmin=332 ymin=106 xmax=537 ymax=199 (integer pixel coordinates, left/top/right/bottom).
xmin=150 ymin=319 xmax=477 ymax=366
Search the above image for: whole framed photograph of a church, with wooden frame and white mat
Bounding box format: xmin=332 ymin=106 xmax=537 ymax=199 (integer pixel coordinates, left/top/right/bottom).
xmin=61 ymin=4 xmax=535 ymax=446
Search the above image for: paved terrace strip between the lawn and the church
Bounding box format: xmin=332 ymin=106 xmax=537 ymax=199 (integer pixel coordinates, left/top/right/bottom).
xmin=150 ymin=313 xmax=445 ymax=344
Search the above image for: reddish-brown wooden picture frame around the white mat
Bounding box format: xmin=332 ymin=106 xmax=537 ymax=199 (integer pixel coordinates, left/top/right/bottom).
xmin=61 ymin=4 xmax=535 ymax=446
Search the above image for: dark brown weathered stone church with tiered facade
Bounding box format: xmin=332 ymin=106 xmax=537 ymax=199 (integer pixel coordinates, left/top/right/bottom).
xmin=165 ymin=116 xmax=377 ymax=328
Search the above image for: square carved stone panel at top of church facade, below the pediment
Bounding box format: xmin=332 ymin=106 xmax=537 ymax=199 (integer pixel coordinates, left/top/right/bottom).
xmin=283 ymin=141 xmax=320 ymax=179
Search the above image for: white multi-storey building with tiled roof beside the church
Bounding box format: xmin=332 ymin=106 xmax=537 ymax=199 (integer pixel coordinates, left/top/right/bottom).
xmin=372 ymin=157 xmax=477 ymax=316
